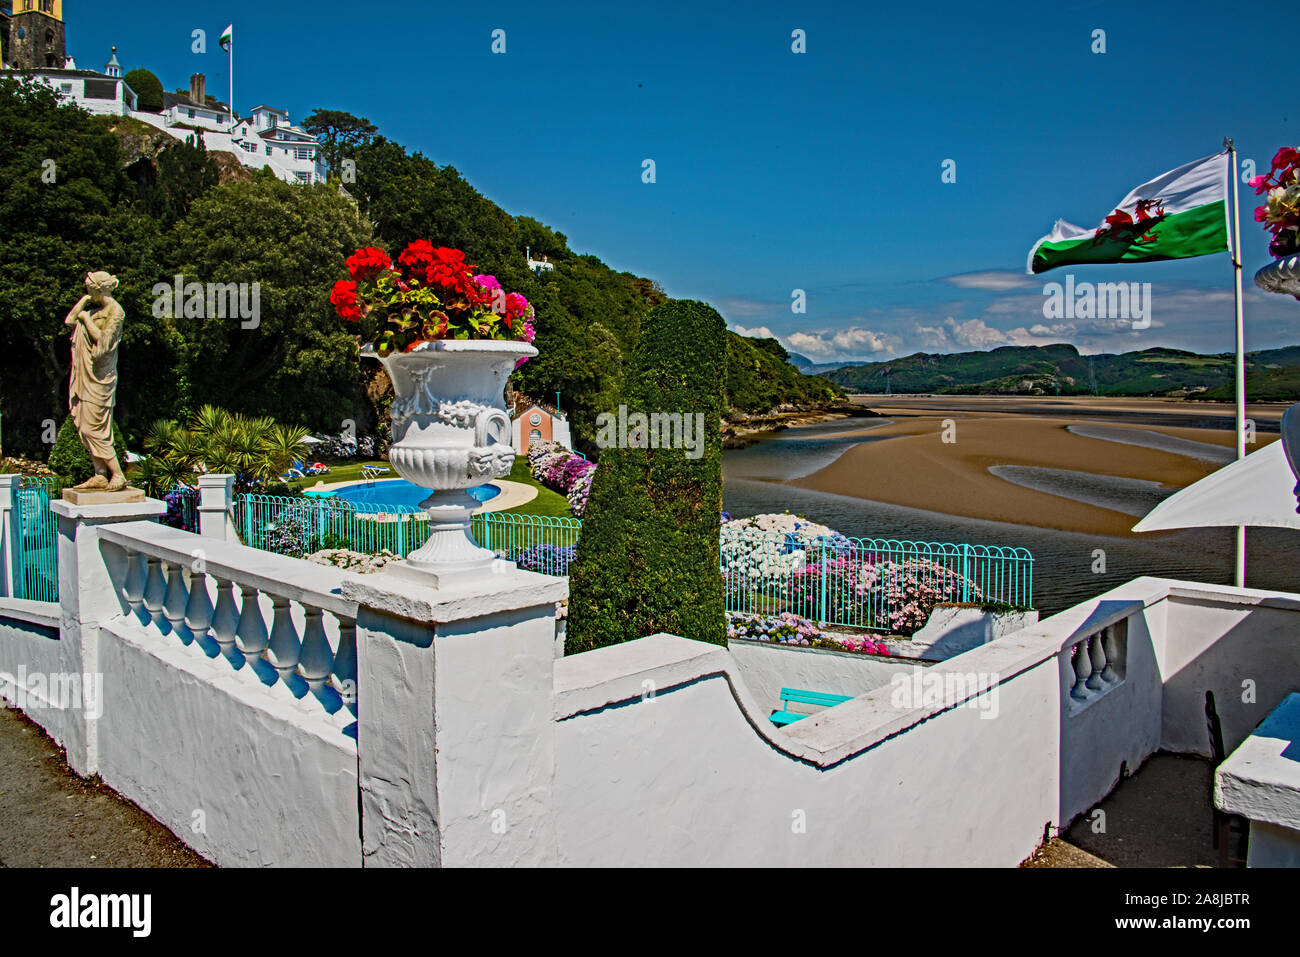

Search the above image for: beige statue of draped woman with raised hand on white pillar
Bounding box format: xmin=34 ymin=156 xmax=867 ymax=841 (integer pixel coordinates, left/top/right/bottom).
xmin=64 ymin=272 xmax=126 ymax=492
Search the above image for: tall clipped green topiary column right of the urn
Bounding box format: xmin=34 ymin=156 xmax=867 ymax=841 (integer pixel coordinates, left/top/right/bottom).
xmin=564 ymin=300 xmax=727 ymax=654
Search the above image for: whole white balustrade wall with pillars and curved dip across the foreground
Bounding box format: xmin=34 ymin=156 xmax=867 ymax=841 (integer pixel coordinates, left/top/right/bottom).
xmin=0 ymin=473 xmax=1300 ymax=866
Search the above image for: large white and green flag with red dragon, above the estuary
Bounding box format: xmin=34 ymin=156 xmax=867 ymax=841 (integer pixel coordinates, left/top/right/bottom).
xmin=1028 ymin=150 xmax=1229 ymax=273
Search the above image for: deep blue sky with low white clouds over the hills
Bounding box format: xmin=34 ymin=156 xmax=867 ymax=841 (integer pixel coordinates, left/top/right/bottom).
xmin=73 ymin=0 xmax=1300 ymax=361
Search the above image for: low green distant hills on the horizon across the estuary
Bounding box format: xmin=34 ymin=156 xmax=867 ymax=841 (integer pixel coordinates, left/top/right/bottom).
xmin=818 ymin=343 xmax=1300 ymax=399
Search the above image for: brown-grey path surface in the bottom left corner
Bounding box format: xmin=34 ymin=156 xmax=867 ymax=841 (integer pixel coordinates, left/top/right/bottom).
xmin=0 ymin=706 xmax=211 ymax=867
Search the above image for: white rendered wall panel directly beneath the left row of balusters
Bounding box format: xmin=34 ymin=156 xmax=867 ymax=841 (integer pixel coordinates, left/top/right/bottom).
xmin=99 ymin=619 xmax=361 ymax=867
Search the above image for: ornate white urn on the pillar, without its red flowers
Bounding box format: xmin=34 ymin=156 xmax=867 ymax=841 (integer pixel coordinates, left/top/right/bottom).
xmin=361 ymin=339 xmax=537 ymax=585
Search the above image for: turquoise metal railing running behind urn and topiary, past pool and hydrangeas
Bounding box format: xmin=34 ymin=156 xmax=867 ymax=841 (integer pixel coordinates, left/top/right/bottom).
xmin=235 ymin=495 xmax=1034 ymax=633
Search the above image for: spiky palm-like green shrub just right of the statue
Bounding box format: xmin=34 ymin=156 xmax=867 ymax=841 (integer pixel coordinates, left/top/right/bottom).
xmin=140 ymin=406 xmax=311 ymax=495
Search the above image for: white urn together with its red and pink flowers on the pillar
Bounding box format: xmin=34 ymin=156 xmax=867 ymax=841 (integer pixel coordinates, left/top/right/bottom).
xmin=330 ymin=239 xmax=537 ymax=585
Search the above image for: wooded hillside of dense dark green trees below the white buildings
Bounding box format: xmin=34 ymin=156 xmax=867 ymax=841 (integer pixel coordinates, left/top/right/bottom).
xmin=0 ymin=79 xmax=835 ymax=456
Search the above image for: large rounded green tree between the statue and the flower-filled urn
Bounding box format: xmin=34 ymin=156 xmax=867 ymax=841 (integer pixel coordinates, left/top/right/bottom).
xmin=166 ymin=177 xmax=371 ymax=432
